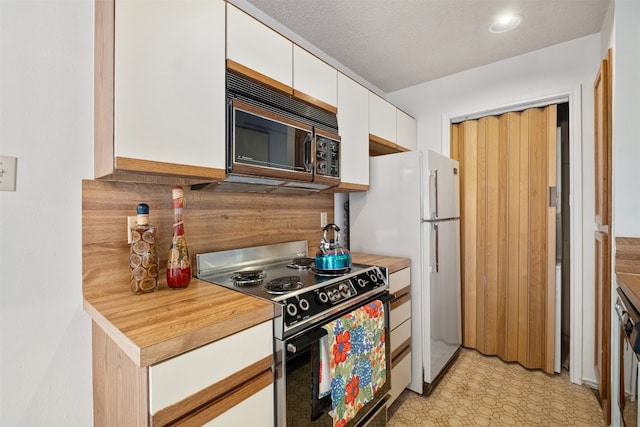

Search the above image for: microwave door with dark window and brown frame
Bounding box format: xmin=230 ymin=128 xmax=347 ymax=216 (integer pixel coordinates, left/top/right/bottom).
xmin=228 ymin=99 xmax=313 ymax=181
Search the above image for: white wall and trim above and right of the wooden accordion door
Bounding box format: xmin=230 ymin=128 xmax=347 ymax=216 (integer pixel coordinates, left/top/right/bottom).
xmin=388 ymin=34 xmax=600 ymax=383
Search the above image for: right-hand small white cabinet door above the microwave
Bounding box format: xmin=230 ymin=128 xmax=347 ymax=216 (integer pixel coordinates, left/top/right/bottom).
xmin=293 ymin=45 xmax=338 ymax=112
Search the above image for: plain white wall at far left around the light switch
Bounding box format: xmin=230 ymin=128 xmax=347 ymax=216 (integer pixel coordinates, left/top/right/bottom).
xmin=0 ymin=0 xmax=93 ymax=427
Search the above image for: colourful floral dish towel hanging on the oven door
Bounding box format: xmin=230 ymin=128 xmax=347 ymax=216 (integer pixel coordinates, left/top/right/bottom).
xmin=320 ymin=300 xmax=387 ymax=427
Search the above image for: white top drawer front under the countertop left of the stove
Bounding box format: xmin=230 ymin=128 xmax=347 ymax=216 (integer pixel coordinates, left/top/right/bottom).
xmin=149 ymin=321 xmax=273 ymax=415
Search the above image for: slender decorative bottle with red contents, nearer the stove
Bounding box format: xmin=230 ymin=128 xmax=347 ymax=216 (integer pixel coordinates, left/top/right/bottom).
xmin=167 ymin=185 xmax=191 ymax=288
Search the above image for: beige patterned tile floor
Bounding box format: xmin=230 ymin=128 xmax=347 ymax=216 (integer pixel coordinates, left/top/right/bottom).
xmin=388 ymin=349 xmax=604 ymax=427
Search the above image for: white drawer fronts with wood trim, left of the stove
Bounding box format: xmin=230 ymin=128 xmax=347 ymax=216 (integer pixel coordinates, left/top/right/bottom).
xmin=149 ymin=321 xmax=274 ymax=427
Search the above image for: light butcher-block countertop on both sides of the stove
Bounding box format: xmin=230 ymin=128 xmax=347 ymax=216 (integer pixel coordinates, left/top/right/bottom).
xmin=84 ymin=253 xmax=411 ymax=367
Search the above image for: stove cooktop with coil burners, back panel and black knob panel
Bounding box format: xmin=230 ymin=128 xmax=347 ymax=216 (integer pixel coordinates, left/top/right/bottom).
xmin=196 ymin=241 xmax=389 ymax=339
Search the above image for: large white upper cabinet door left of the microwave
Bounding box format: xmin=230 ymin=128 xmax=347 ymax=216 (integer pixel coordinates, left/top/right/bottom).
xmin=114 ymin=0 xmax=225 ymax=170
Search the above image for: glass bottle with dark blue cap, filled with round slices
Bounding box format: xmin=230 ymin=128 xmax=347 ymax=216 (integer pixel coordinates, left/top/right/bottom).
xmin=129 ymin=203 xmax=158 ymax=294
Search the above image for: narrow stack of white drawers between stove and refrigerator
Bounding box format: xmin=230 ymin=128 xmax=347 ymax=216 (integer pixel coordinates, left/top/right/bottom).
xmin=388 ymin=267 xmax=411 ymax=405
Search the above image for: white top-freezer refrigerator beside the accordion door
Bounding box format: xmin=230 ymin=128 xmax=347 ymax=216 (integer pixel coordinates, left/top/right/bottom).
xmin=349 ymin=151 xmax=462 ymax=394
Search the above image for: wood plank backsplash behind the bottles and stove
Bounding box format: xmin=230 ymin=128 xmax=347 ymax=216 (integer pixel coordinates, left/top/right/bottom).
xmin=82 ymin=180 xmax=333 ymax=295
